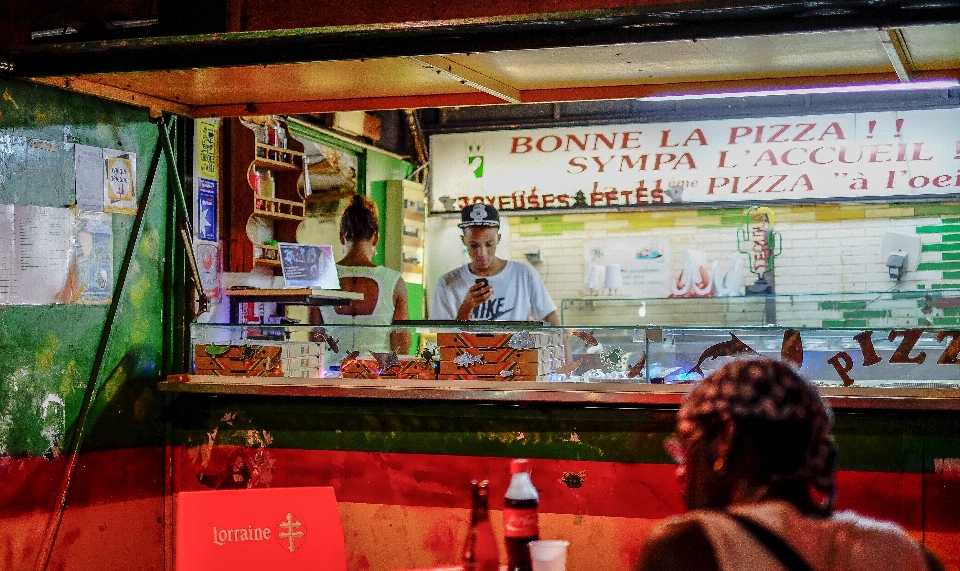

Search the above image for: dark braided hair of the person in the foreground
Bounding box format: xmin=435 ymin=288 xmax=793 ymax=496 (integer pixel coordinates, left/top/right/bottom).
xmin=678 ymin=358 xmax=837 ymax=517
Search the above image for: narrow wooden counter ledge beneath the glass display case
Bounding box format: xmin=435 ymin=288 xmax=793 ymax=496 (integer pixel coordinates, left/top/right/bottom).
xmin=159 ymin=375 xmax=960 ymax=410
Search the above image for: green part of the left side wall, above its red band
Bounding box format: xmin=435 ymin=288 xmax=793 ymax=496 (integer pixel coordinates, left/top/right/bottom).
xmin=0 ymin=78 xmax=167 ymax=455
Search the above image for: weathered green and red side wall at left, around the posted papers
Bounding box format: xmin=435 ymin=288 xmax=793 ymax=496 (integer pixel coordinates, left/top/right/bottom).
xmin=0 ymin=81 xmax=172 ymax=569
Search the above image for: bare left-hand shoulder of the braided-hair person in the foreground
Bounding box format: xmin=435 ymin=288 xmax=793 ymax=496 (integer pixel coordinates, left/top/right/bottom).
xmin=634 ymin=519 xmax=719 ymax=571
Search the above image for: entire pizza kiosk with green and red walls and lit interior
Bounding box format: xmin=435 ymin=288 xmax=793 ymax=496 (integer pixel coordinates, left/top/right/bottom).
xmin=0 ymin=2 xmax=960 ymax=571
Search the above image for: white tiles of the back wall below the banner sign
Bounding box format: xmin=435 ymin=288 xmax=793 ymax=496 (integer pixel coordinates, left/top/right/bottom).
xmin=426 ymin=214 xmax=942 ymax=320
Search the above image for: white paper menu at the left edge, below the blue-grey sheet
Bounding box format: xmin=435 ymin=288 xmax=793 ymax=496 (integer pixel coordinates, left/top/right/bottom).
xmin=0 ymin=204 xmax=79 ymax=305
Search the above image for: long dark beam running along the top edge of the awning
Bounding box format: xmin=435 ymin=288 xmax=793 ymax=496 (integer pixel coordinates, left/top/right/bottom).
xmin=0 ymin=0 xmax=960 ymax=78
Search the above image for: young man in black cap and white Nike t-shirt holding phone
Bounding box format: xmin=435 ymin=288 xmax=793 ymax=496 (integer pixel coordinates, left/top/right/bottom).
xmin=430 ymin=203 xmax=560 ymax=325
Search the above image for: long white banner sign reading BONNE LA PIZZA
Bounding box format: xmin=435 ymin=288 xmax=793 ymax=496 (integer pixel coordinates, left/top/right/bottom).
xmin=430 ymin=109 xmax=960 ymax=211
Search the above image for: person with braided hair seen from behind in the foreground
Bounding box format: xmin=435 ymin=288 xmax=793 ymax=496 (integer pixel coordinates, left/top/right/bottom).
xmin=636 ymin=358 xmax=943 ymax=571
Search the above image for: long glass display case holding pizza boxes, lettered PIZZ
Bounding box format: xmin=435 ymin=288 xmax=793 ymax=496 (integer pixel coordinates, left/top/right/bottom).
xmin=181 ymin=322 xmax=960 ymax=391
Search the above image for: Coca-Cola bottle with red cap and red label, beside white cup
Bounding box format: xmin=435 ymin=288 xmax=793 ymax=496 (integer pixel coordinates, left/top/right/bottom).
xmin=503 ymin=458 xmax=540 ymax=571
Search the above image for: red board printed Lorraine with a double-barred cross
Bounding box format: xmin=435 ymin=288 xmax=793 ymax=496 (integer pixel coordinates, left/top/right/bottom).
xmin=176 ymin=487 xmax=347 ymax=571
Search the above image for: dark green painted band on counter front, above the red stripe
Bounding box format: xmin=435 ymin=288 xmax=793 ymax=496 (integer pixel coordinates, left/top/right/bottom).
xmin=172 ymin=394 xmax=960 ymax=473
